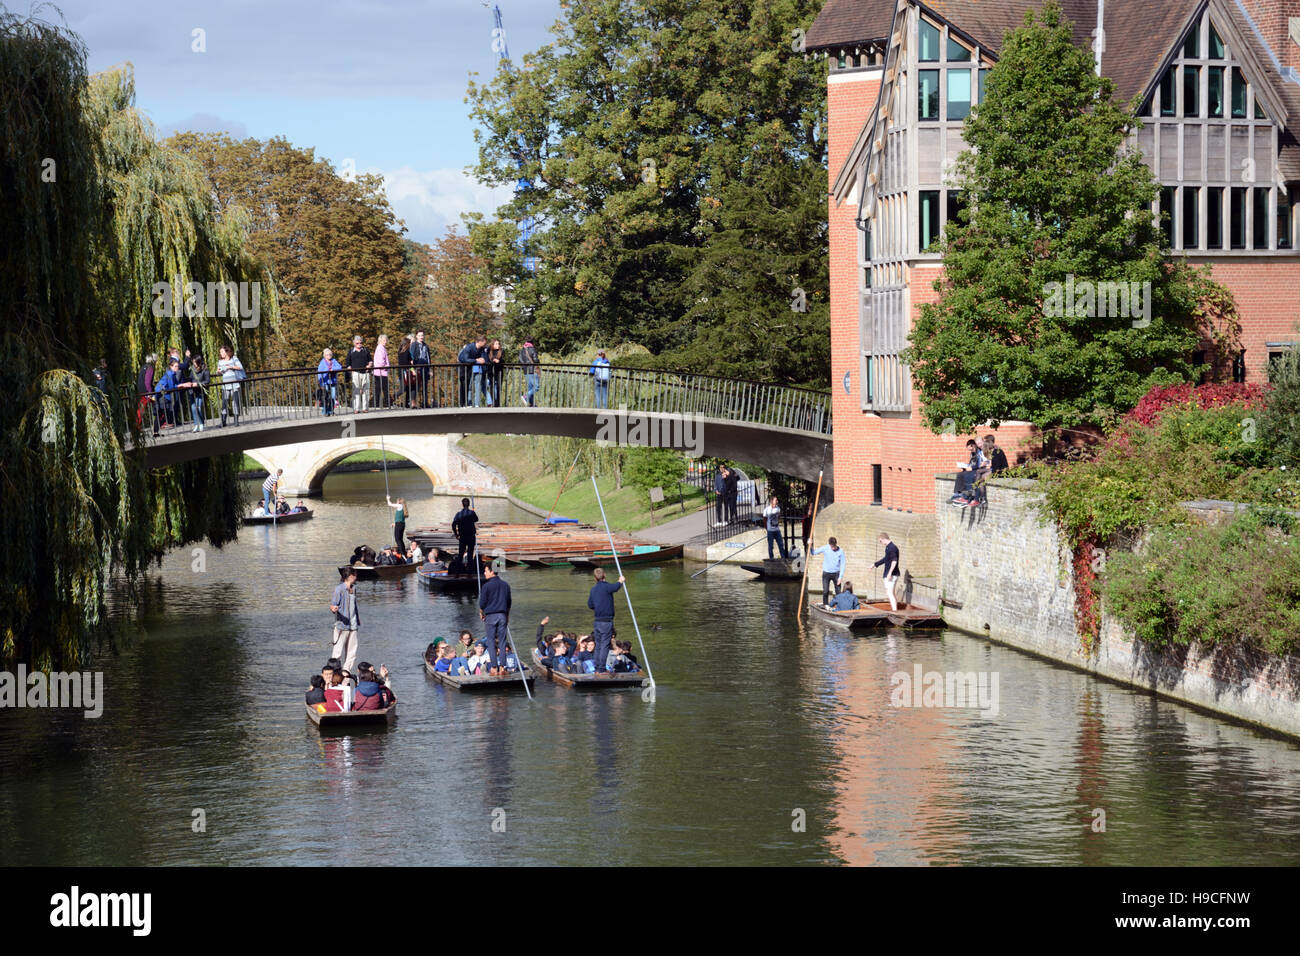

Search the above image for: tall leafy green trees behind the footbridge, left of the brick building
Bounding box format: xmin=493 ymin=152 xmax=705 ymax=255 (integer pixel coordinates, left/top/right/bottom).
xmin=469 ymin=0 xmax=829 ymax=385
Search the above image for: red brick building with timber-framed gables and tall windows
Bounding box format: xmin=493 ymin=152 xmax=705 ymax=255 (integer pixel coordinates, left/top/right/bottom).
xmin=806 ymin=0 xmax=1300 ymax=590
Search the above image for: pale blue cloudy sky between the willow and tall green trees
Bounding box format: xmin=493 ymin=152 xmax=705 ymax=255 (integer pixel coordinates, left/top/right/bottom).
xmin=31 ymin=0 xmax=560 ymax=242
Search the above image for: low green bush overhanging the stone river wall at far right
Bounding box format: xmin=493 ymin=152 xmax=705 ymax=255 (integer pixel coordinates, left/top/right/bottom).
xmin=1102 ymin=511 xmax=1300 ymax=654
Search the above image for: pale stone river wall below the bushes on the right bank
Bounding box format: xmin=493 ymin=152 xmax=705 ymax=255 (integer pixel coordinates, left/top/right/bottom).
xmin=935 ymin=475 xmax=1300 ymax=736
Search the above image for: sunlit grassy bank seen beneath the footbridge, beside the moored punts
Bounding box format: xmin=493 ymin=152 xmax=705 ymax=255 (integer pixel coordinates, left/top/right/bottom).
xmin=460 ymin=434 xmax=705 ymax=531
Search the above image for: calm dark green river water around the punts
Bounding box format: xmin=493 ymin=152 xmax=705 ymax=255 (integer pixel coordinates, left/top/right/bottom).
xmin=0 ymin=471 xmax=1300 ymax=865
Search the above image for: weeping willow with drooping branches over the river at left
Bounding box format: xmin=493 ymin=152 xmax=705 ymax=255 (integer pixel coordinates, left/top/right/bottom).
xmin=0 ymin=10 xmax=276 ymax=669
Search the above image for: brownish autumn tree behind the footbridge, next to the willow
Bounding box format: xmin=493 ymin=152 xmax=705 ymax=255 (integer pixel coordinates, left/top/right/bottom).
xmin=168 ymin=133 xmax=410 ymax=368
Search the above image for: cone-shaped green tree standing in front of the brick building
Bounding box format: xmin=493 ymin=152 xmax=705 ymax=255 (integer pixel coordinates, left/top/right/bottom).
xmin=904 ymin=0 xmax=1231 ymax=432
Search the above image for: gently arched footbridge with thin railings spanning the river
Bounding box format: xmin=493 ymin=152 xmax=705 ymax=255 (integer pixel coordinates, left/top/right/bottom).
xmin=131 ymin=365 xmax=831 ymax=493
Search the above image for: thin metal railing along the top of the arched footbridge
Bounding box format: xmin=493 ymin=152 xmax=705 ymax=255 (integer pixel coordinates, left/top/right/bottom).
xmin=126 ymin=364 xmax=831 ymax=436
